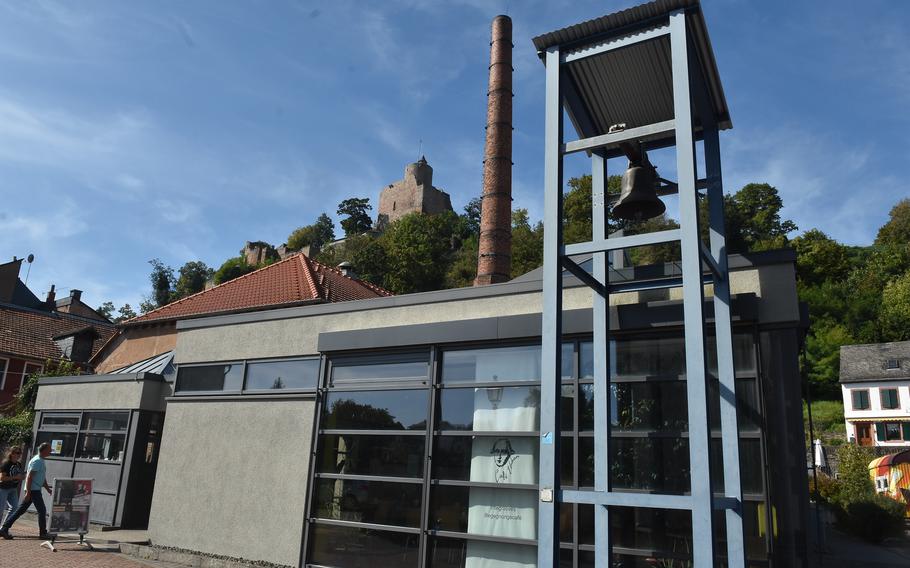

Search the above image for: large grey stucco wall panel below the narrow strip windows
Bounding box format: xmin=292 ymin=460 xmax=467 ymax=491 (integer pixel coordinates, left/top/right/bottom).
xmin=149 ymin=399 xmax=315 ymax=566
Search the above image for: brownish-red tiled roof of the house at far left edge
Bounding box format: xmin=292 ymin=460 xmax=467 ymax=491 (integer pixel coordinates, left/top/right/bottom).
xmin=0 ymin=305 xmax=116 ymax=359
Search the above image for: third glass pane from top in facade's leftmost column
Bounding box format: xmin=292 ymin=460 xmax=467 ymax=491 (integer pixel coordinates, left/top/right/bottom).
xmin=316 ymin=434 xmax=426 ymax=477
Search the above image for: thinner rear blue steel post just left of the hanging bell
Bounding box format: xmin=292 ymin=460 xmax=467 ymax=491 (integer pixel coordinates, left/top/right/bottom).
xmin=591 ymin=152 xmax=611 ymax=568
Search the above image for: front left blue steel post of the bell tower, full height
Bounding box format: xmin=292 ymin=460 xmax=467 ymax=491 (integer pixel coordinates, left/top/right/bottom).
xmin=537 ymin=47 xmax=563 ymax=566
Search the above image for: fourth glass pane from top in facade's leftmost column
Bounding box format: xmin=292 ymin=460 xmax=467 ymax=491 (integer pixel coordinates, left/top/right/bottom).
xmin=313 ymin=479 xmax=423 ymax=527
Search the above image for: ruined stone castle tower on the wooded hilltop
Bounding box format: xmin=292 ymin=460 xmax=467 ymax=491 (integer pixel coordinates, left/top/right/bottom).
xmin=376 ymin=156 xmax=452 ymax=230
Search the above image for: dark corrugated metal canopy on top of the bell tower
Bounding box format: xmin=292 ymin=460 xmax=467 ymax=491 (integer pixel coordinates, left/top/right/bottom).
xmin=534 ymin=0 xmax=732 ymax=141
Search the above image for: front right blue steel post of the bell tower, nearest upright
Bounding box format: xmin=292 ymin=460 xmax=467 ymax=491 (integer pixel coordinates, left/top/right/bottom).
xmin=670 ymin=10 xmax=714 ymax=568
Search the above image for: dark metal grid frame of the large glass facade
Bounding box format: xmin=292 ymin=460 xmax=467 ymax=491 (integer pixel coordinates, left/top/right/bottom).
xmin=300 ymin=324 xmax=771 ymax=566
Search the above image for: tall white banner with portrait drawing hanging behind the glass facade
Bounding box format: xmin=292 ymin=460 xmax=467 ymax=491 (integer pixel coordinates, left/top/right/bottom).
xmin=465 ymin=353 xmax=540 ymax=568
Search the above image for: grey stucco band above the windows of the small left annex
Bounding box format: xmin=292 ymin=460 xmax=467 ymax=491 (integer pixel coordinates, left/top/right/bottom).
xmin=35 ymin=381 xmax=143 ymax=410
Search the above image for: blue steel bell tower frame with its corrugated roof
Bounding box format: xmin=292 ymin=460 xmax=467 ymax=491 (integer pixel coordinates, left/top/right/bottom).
xmin=534 ymin=0 xmax=745 ymax=568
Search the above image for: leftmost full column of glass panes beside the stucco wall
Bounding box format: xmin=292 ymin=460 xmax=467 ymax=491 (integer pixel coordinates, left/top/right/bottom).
xmin=307 ymin=355 xmax=430 ymax=568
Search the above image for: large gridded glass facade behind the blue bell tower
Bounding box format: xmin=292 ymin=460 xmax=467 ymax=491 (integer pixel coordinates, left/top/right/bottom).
xmin=305 ymin=333 xmax=769 ymax=568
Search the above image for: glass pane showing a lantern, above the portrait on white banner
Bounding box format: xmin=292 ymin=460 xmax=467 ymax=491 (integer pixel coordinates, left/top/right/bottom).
xmin=439 ymin=386 xmax=540 ymax=432
